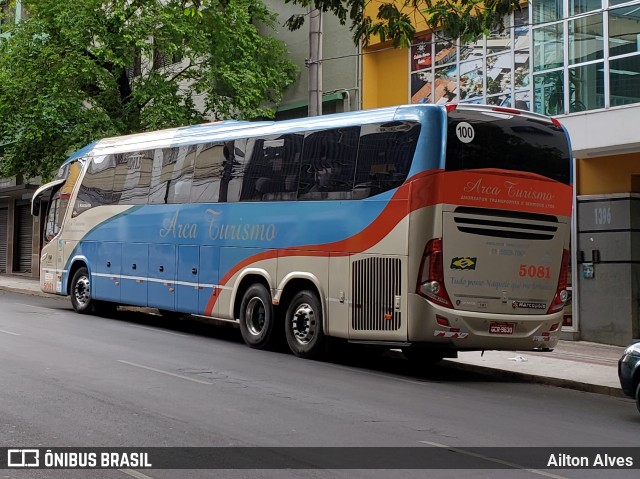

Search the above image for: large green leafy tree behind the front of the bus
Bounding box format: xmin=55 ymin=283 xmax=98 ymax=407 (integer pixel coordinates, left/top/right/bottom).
xmin=0 ymin=0 xmax=297 ymax=177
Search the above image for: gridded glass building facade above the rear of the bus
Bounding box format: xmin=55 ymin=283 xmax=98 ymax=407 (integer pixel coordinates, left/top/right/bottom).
xmin=410 ymin=0 xmax=640 ymax=116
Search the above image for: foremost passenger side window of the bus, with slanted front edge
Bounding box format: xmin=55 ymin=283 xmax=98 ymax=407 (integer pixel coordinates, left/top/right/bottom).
xmin=73 ymin=155 xmax=116 ymax=216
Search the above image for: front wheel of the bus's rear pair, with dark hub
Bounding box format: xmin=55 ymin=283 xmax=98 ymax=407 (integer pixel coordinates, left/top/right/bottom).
xmin=240 ymin=283 xmax=276 ymax=349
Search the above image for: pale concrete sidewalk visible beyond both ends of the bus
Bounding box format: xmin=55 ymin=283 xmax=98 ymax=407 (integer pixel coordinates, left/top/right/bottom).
xmin=0 ymin=275 xmax=624 ymax=397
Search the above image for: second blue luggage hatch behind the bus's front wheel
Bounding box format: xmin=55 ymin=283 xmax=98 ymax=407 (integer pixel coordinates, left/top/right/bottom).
xmin=120 ymin=243 xmax=149 ymax=306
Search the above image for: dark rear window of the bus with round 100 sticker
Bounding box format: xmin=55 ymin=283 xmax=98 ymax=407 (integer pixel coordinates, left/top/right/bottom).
xmin=445 ymin=109 xmax=571 ymax=184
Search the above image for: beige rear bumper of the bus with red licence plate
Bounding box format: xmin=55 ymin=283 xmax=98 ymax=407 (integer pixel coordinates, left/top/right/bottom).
xmin=407 ymin=294 xmax=562 ymax=351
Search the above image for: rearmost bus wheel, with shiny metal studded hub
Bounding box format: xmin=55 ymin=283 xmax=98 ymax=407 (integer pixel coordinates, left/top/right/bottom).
xmin=285 ymin=290 xmax=325 ymax=359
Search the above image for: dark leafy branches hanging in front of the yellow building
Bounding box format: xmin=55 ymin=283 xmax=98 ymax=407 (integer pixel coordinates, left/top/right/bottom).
xmin=284 ymin=0 xmax=521 ymax=47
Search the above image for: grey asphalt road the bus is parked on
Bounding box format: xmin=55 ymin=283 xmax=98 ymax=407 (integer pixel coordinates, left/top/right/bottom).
xmin=0 ymin=292 xmax=640 ymax=479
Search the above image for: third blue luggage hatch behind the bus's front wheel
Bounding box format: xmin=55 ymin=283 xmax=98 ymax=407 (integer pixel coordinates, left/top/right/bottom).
xmin=148 ymin=244 xmax=176 ymax=311
